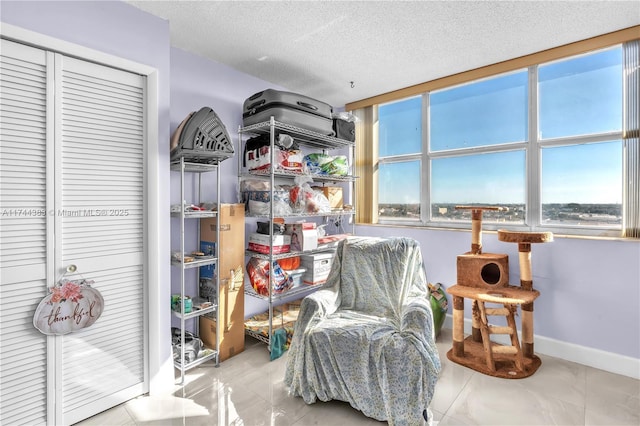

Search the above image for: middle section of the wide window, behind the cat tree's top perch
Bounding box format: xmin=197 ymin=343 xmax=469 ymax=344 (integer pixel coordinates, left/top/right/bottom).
xmin=428 ymin=70 xmax=528 ymax=223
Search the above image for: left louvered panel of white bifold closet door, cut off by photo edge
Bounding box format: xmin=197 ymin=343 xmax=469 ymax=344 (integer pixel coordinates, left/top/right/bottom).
xmin=0 ymin=40 xmax=53 ymax=425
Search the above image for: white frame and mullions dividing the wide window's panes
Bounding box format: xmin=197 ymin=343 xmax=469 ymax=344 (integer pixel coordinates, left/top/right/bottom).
xmin=372 ymin=47 xmax=625 ymax=237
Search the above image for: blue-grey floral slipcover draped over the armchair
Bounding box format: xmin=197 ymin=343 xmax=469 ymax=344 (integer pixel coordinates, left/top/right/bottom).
xmin=285 ymin=237 xmax=441 ymax=425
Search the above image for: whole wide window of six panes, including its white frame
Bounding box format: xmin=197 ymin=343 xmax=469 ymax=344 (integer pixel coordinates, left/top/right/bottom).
xmin=370 ymin=46 xmax=624 ymax=235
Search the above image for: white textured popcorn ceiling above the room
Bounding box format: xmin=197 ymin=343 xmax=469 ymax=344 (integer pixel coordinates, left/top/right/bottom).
xmin=127 ymin=0 xmax=640 ymax=107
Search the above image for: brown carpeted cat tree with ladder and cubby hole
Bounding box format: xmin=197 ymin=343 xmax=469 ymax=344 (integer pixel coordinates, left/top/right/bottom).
xmin=447 ymin=206 xmax=553 ymax=379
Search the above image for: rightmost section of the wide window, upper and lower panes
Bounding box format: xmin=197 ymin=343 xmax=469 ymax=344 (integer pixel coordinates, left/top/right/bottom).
xmin=537 ymin=47 xmax=623 ymax=229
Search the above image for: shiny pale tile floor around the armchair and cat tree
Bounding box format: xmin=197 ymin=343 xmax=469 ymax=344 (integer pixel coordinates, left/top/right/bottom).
xmin=78 ymin=329 xmax=640 ymax=426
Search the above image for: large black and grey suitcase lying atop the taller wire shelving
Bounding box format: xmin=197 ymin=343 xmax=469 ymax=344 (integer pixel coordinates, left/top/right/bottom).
xmin=242 ymin=89 xmax=335 ymax=136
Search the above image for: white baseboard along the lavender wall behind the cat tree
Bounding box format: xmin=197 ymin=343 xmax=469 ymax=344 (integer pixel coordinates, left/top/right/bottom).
xmin=443 ymin=314 xmax=640 ymax=380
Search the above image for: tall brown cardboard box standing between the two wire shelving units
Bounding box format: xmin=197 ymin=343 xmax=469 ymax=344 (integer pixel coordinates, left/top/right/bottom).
xmin=199 ymin=203 xmax=244 ymax=362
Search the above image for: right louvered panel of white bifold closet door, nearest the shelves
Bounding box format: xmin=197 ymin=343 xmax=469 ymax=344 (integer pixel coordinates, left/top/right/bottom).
xmin=55 ymin=55 xmax=148 ymax=424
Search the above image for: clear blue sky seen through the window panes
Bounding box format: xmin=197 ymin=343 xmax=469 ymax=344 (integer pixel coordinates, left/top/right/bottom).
xmin=379 ymin=48 xmax=622 ymax=204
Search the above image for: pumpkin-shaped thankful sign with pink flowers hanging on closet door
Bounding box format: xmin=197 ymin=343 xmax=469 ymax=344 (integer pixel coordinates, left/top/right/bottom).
xmin=33 ymin=272 xmax=104 ymax=335
